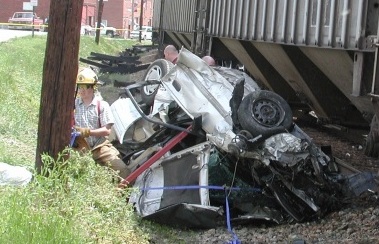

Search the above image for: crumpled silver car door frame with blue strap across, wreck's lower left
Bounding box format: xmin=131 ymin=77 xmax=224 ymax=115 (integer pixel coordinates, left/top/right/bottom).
xmin=129 ymin=142 xmax=214 ymax=216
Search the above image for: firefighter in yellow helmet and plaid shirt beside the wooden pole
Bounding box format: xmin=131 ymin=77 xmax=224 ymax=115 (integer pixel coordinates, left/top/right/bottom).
xmin=74 ymin=68 xmax=130 ymax=179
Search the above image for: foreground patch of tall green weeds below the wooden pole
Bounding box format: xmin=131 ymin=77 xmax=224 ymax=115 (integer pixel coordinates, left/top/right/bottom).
xmin=0 ymin=149 xmax=148 ymax=243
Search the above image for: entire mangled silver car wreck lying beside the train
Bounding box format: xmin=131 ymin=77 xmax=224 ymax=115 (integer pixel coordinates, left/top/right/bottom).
xmin=111 ymin=48 xmax=376 ymax=228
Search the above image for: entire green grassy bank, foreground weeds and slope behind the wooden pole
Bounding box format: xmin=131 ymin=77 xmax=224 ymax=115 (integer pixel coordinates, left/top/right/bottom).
xmin=0 ymin=36 xmax=196 ymax=243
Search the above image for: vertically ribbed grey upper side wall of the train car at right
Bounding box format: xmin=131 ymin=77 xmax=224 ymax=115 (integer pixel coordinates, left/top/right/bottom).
xmin=209 ymin=0 xmax=379 ymax=50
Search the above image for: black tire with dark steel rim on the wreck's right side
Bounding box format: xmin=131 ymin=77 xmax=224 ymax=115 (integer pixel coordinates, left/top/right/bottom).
xmin=238 ymin=90 xmax=293 ymax=138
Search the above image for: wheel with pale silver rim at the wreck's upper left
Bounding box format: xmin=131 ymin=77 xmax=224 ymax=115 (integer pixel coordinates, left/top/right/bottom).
xmin=141 ymin=59 xmax=174 ymax=106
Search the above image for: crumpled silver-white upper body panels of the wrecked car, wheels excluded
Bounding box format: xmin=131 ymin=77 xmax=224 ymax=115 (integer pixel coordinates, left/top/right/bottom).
xmin=111 ymin=48 xmax=259 ymax=151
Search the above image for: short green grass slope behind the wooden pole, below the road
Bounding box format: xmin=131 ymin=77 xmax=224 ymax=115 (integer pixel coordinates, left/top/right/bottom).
xmin=0 ymin=36 xmax=140 ymax=166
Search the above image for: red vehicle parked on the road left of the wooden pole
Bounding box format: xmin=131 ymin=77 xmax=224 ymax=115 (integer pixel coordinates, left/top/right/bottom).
xmin=8 ymin=12 xmax=43 ymax=31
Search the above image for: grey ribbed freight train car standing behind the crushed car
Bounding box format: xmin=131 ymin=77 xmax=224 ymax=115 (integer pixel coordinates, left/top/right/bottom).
xmin=153 ymin=0 xmax=379 ymax=155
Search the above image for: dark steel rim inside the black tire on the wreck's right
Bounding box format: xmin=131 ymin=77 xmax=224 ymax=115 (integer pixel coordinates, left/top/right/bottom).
xmin=252 ymin=99 xmax=284 ymax=127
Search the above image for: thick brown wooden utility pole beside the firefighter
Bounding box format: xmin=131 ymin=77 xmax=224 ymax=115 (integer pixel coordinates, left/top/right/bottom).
xmin=35 ymin=0 xmax=83 ymax=172
